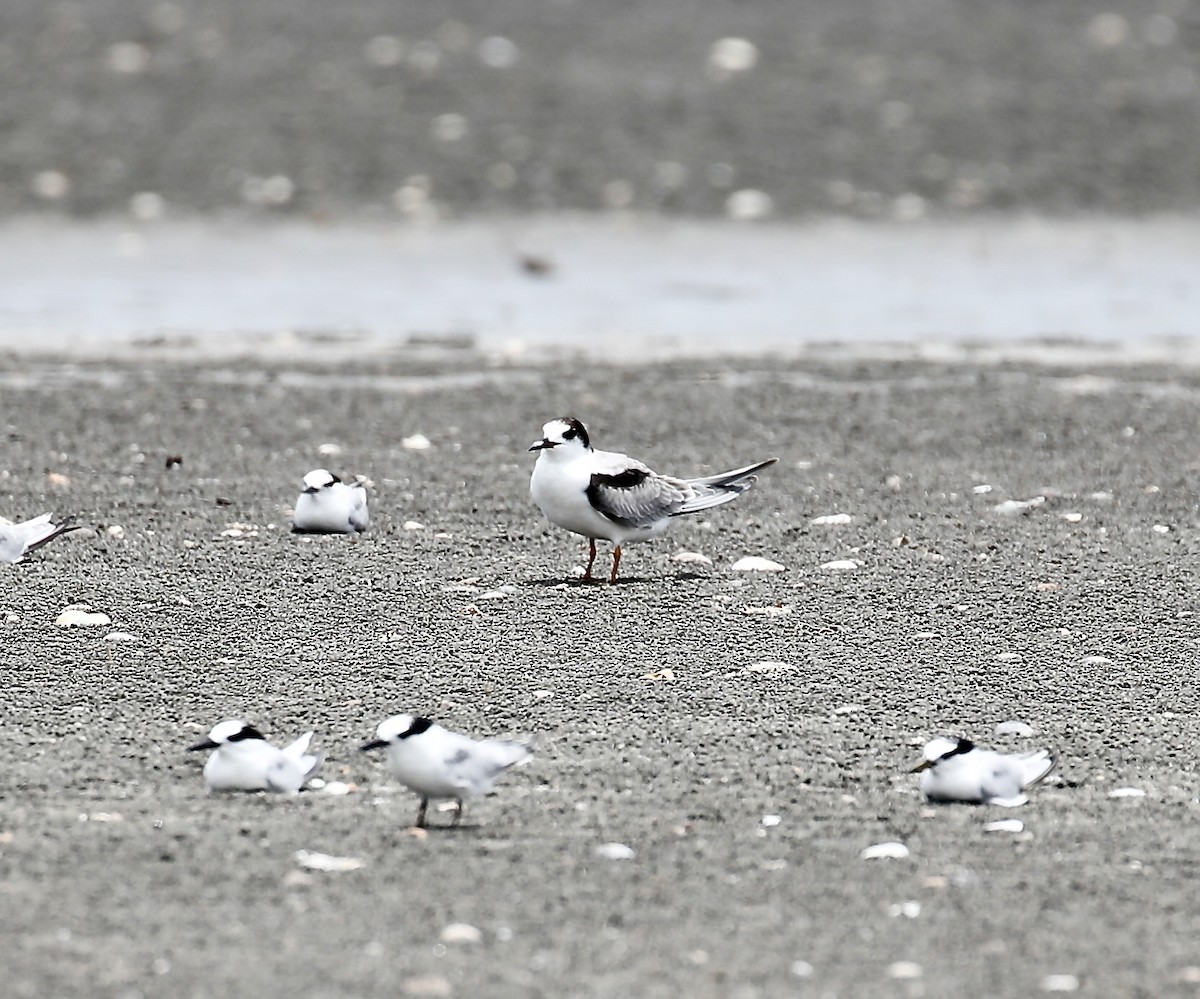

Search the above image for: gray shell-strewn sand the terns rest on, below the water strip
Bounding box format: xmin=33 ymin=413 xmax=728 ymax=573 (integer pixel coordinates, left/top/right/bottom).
xmin=0 ymin=348 xmax=1200 ymax=997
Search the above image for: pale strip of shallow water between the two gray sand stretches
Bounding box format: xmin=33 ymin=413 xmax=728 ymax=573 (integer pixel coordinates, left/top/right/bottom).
xmin=0 ymin=216 xmax=1200 ymax=360
